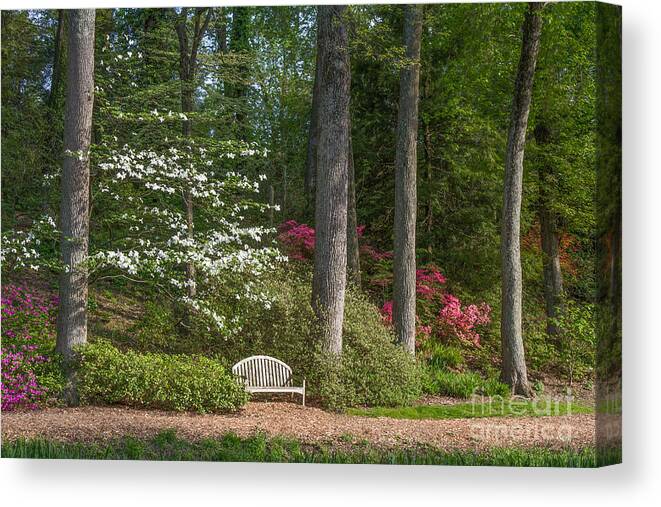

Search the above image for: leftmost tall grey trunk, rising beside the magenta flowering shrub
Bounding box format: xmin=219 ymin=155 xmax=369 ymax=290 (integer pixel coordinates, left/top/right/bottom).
xmin=56 ymin=9 xmax=95 ymax=404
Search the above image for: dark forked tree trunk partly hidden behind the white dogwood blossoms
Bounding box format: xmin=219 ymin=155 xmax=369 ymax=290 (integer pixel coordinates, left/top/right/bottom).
xmin=175 ymin=8 xmax=211 ymax=314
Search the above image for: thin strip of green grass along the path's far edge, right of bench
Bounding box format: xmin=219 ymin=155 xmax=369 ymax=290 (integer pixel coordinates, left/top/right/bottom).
xmin=347 ymin=399 xmax=594 ymax=419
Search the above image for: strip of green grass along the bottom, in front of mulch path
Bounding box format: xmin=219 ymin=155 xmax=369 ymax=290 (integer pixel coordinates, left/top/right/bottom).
xmin=2 ymin=431 xmax=621 ymax=468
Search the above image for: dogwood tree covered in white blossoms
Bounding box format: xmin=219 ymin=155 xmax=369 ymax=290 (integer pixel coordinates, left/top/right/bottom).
xmin=90 ymin=142 xmax=285 ymax=335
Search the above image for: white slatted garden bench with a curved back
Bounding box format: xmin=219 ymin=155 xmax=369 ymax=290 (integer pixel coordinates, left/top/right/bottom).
xmin=232 ymin=356 xmax=305 ymax=406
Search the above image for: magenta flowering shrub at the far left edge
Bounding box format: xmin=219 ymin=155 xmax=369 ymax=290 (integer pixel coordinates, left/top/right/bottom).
xmin=0 ymin=285 xmax=57 ymax=411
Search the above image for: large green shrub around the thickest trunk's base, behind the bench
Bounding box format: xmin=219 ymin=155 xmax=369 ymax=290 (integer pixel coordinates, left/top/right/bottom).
xmin=185 ymin=272 xmax=422 ymax=409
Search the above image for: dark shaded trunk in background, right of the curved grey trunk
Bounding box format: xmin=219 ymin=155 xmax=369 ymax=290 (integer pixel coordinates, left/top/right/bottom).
xmin=535 ymin=120 xmax=563 ymax=339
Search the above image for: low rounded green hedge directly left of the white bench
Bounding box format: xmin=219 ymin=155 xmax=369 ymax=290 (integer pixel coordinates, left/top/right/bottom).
xmin=78 ymin=341 xmax=247 ymax=412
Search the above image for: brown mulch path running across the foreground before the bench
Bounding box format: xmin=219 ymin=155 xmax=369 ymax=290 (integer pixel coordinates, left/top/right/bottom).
xmin=2 ymin=402 xmax=595 ymax=450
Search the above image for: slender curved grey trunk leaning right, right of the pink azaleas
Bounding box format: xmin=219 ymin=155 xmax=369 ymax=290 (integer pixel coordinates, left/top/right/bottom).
xmin=500 ymin=2 xmax=544 ymax=396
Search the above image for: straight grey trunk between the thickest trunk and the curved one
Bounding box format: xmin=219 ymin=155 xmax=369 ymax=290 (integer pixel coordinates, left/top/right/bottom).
xmin=393 ymin=5 xmax=423 ymax=354
